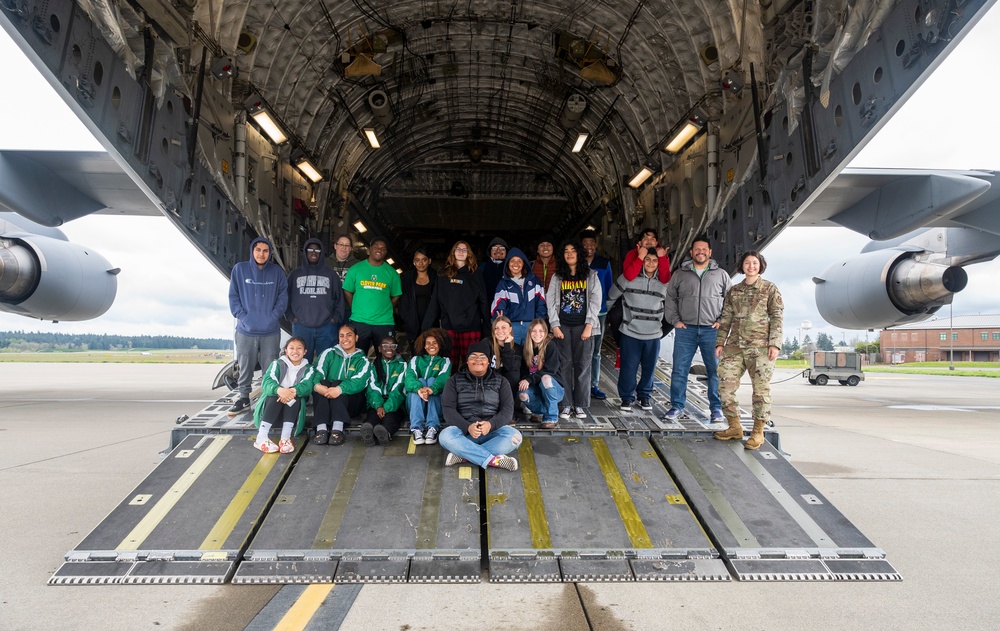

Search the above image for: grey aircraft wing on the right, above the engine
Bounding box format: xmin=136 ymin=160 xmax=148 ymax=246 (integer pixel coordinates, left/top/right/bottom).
xmin=792 ymin=168 xmax=1000 ymax=241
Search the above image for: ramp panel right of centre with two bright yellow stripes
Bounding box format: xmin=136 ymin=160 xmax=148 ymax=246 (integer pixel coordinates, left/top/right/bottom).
xmin=486 ymin=436 xmax=729 ymax=582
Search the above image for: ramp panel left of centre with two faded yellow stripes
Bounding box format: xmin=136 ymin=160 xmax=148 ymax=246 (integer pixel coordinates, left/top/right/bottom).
xmin=233 ymin=434 xmax=482 ymax=583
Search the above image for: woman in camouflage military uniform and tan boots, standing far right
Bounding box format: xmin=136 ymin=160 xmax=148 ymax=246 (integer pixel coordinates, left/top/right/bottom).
xmin=715 ymin=250 xmax=784 ymax=449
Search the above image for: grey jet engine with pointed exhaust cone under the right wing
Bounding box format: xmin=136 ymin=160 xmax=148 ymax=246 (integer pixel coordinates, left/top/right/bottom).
xmin=813 ymin=248 xmax=969 ymax=329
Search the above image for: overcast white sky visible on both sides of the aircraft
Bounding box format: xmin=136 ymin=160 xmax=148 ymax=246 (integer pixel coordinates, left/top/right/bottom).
xmin=0 ymin=8 xmax=1000 ymax=341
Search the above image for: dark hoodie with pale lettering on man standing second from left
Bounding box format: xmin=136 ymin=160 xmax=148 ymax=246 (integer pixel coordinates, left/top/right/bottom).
xmin=286 ymin=239 xmax=344 ymax=328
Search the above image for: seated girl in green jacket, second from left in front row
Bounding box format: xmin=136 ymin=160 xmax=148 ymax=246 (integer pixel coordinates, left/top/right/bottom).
xmin=313 ymin=324 xmax=371 ymax=445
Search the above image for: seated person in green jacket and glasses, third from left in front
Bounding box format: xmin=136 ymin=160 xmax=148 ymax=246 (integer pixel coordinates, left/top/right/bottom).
xmin=361 ymin=335 xmax=406 ymax=447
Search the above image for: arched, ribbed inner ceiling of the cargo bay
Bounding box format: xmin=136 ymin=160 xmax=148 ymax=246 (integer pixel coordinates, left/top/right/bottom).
xmin=186 ymin=0 xmax=812 ymax=242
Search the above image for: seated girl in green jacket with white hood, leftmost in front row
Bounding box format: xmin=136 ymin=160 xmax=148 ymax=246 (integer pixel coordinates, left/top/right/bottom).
xmin=253 ymin=337 xmax=315 ymax=454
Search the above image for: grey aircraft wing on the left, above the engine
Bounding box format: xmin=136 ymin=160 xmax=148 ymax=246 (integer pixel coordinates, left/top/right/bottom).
xmin=0 ymin=150 xmax=162 ymax=226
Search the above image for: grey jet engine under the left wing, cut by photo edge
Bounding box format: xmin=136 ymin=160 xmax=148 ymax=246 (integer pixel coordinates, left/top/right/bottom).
xmin=0 ymin=233 xmax=121 ymax=321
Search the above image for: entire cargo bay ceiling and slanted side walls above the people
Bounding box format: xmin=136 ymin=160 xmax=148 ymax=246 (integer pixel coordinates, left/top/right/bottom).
xmin=21 ymin=0 xmax=976 ymax=264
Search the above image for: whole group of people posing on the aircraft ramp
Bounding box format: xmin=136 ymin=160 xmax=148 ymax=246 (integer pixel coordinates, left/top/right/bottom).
xmin=229 ymin=230 xmax=781 ymax=470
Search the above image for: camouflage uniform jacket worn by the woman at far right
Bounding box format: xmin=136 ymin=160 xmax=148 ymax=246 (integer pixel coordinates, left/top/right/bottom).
xmin=716 ymin=278 xmax=785 ymax=348
